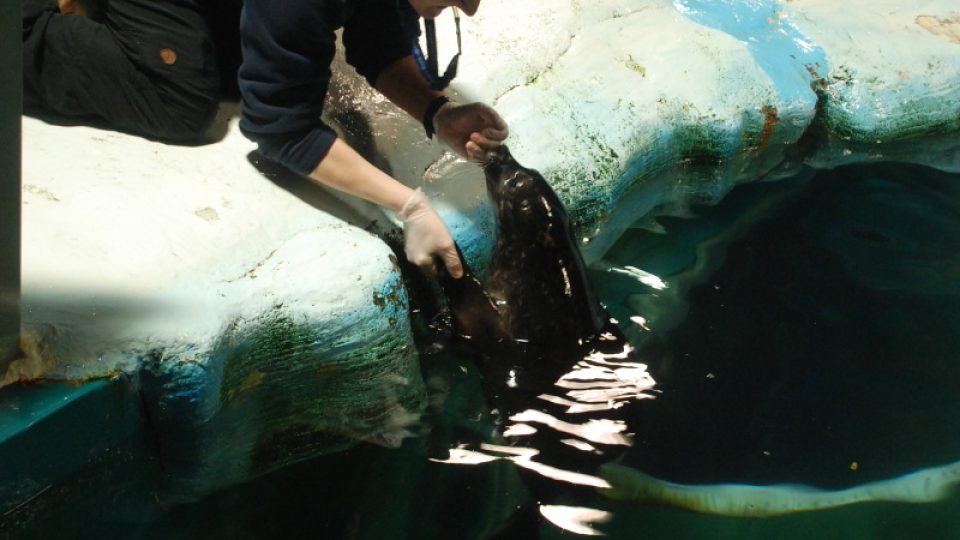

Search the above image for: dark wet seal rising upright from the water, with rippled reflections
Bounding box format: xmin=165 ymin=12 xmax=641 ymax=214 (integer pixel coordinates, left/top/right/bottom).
xmin=441 ymin=147 xmax=654 ymax=488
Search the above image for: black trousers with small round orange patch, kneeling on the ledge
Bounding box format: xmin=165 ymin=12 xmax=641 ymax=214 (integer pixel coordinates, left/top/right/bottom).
xmin=22 ymin=0 xmax=240 ymax=142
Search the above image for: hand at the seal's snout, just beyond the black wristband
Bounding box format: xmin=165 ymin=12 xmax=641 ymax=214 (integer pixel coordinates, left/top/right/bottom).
xmin=433 ymin=101 xmax=509 ymax=161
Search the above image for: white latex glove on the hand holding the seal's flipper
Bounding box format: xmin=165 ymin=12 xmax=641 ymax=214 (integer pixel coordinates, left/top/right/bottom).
xmin=400 ymin=188 xmax=463 ymax=278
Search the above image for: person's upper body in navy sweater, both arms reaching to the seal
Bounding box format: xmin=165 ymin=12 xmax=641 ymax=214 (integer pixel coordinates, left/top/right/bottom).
xmin=239 ymin=0 xmax=507 ymax=277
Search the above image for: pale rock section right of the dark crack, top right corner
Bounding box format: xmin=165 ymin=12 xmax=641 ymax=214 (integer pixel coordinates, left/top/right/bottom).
xmin=783 ymin=0 xmax=960 ymax=143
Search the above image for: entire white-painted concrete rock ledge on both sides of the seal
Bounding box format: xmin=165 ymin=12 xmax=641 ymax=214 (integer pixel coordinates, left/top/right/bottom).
xmin=9 ymin=0 xmax=960 ymax=496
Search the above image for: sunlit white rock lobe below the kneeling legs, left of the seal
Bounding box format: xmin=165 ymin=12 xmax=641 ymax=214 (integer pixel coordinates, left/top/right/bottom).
xmin=13 ymin=118 xmax=424 ymax=495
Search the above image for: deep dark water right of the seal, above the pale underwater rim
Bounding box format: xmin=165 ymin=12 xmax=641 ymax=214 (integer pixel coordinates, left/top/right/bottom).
xmin=608 ymin=164 xmax=960 ymax=488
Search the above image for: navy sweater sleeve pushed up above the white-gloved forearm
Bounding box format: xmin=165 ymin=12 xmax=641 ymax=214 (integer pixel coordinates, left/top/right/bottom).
xmin=239 ymin=0 xmax=340 ymax=174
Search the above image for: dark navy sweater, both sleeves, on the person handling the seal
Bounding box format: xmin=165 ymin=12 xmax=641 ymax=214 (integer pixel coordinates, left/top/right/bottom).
xmin=239 ymin=0 xmax=417 ymax=174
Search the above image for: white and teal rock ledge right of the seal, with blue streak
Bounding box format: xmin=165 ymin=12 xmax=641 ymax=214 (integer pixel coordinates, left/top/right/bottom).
xmin=336 ymin=0 xmax=960 ymax=261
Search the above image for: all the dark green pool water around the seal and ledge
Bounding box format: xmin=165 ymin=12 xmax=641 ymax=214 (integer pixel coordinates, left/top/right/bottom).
xmin=0 ymin=164 xmax=960 ymax=540
